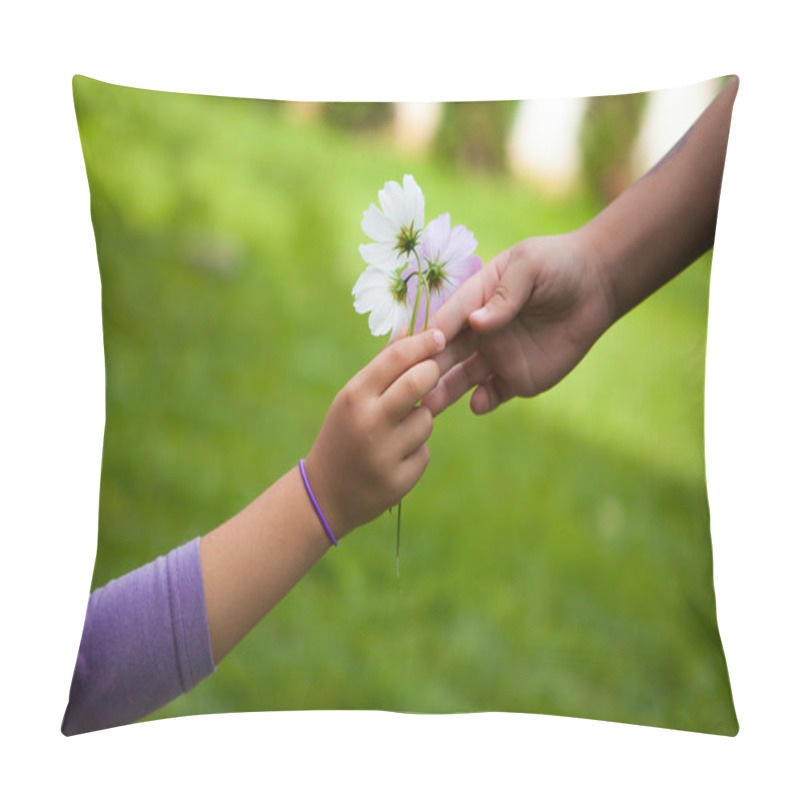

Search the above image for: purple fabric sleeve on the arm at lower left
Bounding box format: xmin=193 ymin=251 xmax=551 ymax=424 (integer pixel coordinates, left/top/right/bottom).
xmin=61 ymin=538 xmax=214 ymax=736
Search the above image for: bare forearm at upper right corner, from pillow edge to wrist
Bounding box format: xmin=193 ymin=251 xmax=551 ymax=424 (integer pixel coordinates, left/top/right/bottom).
xmin=577 ymin=76 xmax=739 ymax=319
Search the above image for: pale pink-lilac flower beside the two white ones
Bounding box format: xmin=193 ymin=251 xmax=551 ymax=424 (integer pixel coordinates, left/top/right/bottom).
xmin=403 ymin=214 xmax=482 ymax=333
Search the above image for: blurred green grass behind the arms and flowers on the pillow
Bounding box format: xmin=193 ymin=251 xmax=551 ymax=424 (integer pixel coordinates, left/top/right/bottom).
xmin=74 ymin=77 xmax=738 ymax=734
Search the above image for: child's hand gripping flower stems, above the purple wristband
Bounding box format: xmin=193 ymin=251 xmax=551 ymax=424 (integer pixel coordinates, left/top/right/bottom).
xmin=306 ymin=330 xmax=445 ymax=537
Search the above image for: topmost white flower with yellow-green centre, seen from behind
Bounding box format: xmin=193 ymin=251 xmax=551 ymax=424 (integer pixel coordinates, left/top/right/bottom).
xmin=358 ymin=175 xmax=425 ymax=273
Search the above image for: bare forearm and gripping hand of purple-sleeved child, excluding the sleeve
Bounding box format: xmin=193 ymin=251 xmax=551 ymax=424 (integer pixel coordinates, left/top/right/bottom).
xmin=200 ymin=330 xmax=444 ymax=664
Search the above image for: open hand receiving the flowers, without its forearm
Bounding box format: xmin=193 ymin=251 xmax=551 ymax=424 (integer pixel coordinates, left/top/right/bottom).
xmin=422 ymin=230 xmax=613 ymax=414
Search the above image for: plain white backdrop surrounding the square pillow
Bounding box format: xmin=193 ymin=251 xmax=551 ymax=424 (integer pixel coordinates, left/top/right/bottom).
xmin=0 ymin=0 xmax=800 ymax=798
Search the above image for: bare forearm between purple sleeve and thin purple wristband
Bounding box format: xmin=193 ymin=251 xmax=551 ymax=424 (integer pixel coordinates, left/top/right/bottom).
xmin=200 ymin=468 xmax=331 ymax=664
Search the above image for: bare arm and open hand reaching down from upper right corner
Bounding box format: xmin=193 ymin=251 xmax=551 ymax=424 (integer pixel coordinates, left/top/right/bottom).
xmin=423 ymin=77 xmax=739 ymax=414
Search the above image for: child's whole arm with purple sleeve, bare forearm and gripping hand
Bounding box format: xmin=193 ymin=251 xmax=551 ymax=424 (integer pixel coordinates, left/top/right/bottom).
xmin=62 ymin=330 xmax=444 ymax=735
